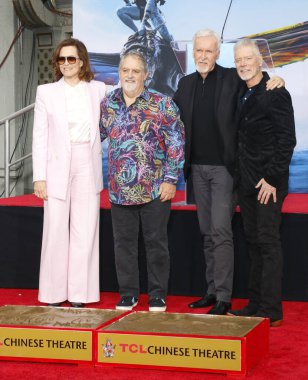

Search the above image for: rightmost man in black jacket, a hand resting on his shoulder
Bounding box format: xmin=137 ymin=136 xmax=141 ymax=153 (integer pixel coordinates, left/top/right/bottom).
xmin=231 ymin=38 xmax=296 ymax=327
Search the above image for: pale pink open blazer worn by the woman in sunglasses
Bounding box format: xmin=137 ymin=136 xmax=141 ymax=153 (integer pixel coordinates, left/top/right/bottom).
xmin=32 ymin=78 xmax=106 ymax=200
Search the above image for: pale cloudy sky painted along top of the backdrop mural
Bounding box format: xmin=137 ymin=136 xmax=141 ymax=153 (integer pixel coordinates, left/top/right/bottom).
xmin=73 ymin=0 xmax=308 ymax=53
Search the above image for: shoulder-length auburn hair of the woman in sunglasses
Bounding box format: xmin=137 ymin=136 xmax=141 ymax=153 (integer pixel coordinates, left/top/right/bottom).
xmin=52 ymin=38 xmax=94 ymax=82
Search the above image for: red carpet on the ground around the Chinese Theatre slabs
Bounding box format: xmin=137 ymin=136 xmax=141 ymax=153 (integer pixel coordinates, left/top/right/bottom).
xmin=0 ymin=289 xmax=308 ymax=380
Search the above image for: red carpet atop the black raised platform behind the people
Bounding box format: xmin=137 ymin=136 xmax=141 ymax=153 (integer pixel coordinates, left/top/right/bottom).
xmin=0 ymin=190 xmax=308 ymax=214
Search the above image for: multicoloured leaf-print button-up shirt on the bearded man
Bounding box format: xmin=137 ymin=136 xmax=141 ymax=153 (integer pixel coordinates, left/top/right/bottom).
xmin=100 ymin=88 xmax=184 ymax=205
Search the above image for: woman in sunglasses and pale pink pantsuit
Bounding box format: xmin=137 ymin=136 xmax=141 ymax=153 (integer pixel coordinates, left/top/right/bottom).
xmin=33 ymin=38 xmax=106 ymax=307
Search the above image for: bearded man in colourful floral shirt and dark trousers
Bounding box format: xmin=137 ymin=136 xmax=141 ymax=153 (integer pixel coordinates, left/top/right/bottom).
xmin=100 ymin=50 xmax=184 ymax=311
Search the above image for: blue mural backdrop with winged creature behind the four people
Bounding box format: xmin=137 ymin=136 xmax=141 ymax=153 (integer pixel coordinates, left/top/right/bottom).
xmin=73 ymin=0 xmax=308 ymax=193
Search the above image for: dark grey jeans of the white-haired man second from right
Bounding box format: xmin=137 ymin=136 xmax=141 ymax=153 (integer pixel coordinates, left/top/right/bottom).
xmin=191 ymin=165 xmax=234 ymax=302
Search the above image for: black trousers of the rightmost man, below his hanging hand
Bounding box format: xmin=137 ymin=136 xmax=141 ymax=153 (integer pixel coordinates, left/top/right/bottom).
xmin=239 ymin=189 xmax=287 ymax=320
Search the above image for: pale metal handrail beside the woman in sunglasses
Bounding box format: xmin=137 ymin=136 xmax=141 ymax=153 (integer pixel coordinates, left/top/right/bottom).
xmin=0 ymin=103 xmax=34 ymax=198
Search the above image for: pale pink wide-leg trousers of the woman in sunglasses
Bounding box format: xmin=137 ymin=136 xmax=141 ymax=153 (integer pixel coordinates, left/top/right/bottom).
xmin=38 ymin=143 xmax=100 ymax=303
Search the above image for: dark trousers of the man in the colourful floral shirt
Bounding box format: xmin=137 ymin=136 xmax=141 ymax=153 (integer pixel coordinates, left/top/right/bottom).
xmin=111 ymin=198 xmax=170 ymax=298
